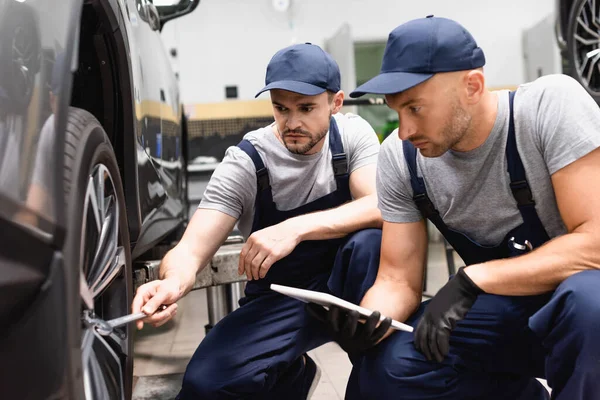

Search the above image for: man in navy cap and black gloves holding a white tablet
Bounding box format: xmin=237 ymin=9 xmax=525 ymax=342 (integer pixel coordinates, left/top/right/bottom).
xmin=312 ymin=17 xmax=600 ymax=400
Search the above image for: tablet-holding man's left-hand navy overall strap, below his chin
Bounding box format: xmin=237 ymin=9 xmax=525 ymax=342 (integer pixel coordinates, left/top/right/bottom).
xmin=402 ymin=140 xmax=448 ymax=235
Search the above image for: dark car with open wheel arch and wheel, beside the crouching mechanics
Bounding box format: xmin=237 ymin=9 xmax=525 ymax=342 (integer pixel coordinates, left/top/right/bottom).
xmin=0 ymin=0 xmax=199 ymax=400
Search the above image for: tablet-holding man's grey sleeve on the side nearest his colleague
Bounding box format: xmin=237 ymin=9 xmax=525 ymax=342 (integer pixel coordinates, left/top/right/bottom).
xmin=377 ymin=132 xmax=422 ymax=223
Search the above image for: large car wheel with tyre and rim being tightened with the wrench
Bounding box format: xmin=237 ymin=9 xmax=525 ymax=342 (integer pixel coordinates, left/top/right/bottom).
xmin=64 ymin=108 xmax=133 ymax=400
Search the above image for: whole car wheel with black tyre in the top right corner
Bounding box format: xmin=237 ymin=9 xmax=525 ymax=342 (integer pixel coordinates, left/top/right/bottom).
xmin=567 ymin=0 xmax=600 ymax=102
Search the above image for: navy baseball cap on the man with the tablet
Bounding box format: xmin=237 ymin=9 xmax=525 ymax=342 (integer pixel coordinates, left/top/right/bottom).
xmin=350 ymin=15 xmax=485 ymax=97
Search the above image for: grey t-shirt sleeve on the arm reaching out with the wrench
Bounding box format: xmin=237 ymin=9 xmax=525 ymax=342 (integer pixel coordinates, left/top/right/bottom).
xmin=198 ymin=146 xmax=256 ymax=219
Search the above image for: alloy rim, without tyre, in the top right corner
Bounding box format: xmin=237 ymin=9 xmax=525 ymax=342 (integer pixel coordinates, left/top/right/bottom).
xmin=572 ymin=0 xmax=600 ymax=95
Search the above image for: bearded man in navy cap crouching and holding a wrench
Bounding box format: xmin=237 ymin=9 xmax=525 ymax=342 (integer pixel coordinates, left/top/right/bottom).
xmin=133 ymin=44 xmax=391 ymax=400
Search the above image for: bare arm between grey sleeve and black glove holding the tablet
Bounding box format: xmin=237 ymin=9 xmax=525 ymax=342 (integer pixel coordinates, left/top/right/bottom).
xmin=361 ymin=220 xmax=427 ymax=334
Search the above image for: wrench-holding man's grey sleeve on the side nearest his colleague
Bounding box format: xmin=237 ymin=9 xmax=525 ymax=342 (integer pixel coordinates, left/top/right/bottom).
xmin=344 ymin=114 xmax=379 ymax=173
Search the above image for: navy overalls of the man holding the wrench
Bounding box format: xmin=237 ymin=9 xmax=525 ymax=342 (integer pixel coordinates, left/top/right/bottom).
xmin=178 ymin=118 xmax=381 ymax=400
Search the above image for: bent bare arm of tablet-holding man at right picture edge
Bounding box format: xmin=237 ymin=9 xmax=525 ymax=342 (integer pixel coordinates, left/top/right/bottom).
xmin=465 ymin=149 xmax=600 ymax=296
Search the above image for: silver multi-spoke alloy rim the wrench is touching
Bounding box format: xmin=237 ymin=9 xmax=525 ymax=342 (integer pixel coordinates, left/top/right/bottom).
xmin=79 ymin=164 xmax=130 ymax=400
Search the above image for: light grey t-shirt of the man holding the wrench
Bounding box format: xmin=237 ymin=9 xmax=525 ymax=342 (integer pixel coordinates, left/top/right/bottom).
xmin=198 ymin=113 xmax=379 ymax=237
